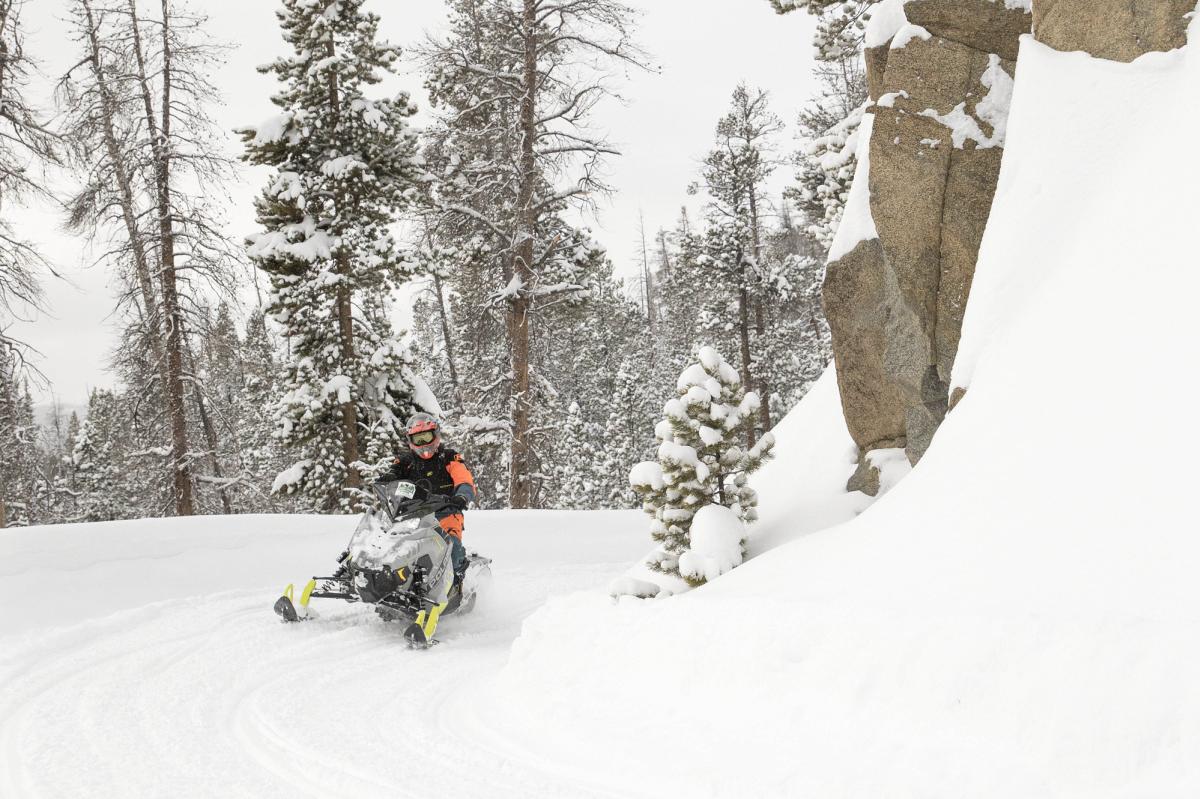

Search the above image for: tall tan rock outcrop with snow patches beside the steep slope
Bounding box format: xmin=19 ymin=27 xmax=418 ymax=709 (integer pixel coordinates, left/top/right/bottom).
xmin=824 ymin=0 xmax=1031 ymax=492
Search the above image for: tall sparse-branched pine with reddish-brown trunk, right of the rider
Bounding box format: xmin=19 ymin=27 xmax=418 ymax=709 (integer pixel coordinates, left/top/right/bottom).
xmin=424 ymin=0 xmax=644 ymax=507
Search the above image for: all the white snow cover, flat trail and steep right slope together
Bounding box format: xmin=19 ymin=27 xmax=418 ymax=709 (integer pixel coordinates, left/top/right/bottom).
xmin=9 ymin=20 xmax=1200 ymax=799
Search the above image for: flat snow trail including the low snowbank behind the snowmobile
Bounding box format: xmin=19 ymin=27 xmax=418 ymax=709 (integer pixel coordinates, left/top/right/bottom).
xmin=0 ymin=512 xmax=646 ymax=799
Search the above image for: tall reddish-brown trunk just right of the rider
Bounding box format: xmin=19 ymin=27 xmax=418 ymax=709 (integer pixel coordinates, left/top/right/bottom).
xmin=508 ymin=0 xmax=538 ymax=507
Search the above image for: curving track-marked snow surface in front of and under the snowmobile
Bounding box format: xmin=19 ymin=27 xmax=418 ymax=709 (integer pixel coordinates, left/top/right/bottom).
xmin=0 ymin=567 xmax=628 ymax=799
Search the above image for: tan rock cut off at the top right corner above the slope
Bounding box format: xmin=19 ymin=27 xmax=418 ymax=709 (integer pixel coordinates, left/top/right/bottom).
xmin=1033 ymin=0 xmax=1196 ymax=61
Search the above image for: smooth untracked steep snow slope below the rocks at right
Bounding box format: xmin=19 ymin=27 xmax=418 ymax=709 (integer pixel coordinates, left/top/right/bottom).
xmin=472 ymin=22 xmax=1200 ymax=798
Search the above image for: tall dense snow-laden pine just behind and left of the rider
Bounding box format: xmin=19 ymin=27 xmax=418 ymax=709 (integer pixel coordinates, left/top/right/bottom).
xmin=241 ymin=0 xmax=433 ymax=510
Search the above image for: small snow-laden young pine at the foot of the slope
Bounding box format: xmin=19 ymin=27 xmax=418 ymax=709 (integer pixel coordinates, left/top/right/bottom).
xmin=630 ymin=347 xmax=775 ymax=585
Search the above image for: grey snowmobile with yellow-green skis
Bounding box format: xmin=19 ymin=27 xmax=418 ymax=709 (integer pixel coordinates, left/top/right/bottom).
xmin=275 ymin=480 xmax=492 ymax=648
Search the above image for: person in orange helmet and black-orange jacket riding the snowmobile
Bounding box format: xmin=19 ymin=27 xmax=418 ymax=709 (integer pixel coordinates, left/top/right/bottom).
xmin=376 ymin=413 xmax=475 ymax=578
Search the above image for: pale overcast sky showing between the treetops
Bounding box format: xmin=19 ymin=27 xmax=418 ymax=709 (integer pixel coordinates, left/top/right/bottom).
xmin=6 ymin=0 xmax=812 ymax=404
